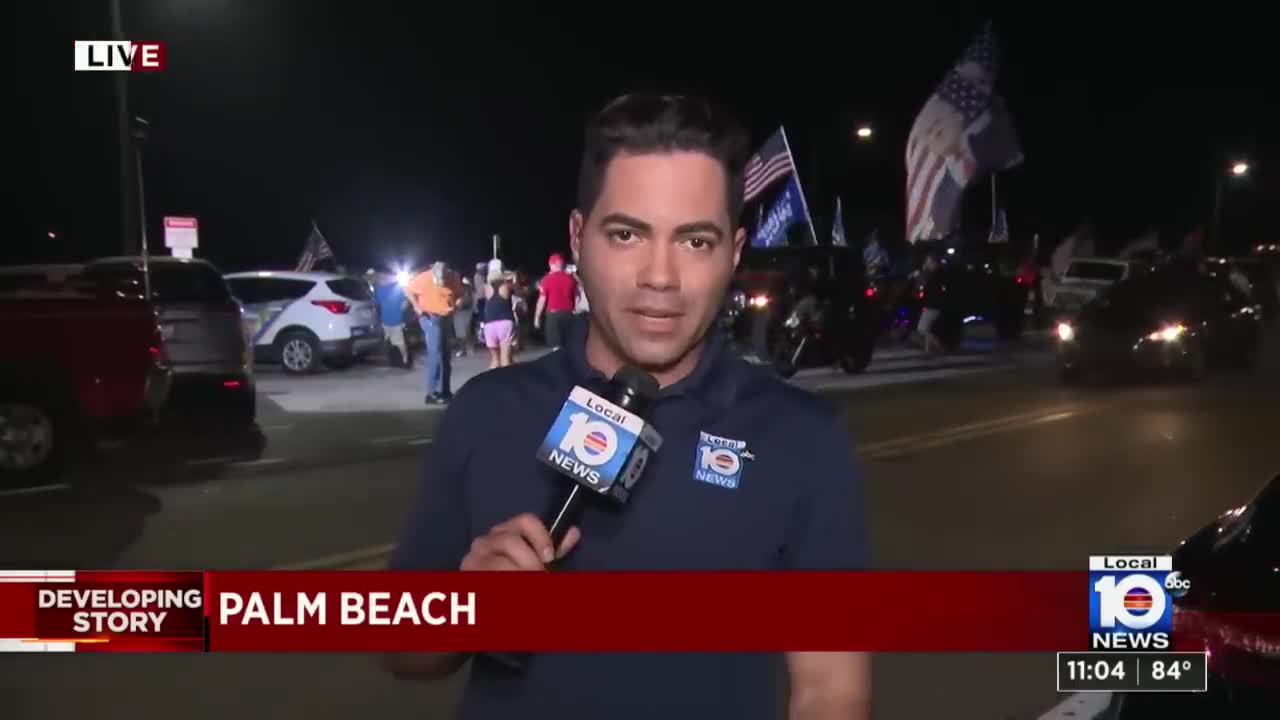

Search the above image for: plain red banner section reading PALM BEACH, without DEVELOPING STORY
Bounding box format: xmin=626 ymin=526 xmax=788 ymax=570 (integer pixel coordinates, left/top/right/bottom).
xmin=207 ymin=571 xmax=1088 ymax=652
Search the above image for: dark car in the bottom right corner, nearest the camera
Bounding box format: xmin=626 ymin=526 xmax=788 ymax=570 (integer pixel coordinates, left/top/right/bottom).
xmin=1103 ymin=475 xmax=1280 ymax=720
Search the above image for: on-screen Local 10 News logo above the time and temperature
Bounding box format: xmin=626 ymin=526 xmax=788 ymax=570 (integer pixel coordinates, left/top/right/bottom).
xmin=1089 ymin=555 xmax=1192 ymax=650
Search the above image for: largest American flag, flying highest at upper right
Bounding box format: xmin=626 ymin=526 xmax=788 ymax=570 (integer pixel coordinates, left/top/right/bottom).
xmin=906 ymin=26 xmax=1023 ymax=242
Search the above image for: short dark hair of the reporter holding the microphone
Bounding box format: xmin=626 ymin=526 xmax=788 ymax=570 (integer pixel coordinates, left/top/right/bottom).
xmin=577 ymin=94 xmax=750 ymax=225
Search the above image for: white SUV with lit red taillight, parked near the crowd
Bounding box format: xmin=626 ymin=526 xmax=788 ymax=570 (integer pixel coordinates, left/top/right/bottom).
xmin=225 ymin=270 xmax=383 ymax=374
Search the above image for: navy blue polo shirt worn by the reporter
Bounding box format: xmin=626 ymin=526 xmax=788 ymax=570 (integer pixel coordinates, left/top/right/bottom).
xmin=392 ymin=320 xmax=868 ymax=720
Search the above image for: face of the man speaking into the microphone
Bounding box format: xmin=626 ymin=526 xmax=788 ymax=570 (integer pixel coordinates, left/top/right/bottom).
xmin=570 ymin=152 xmax=746 ymax=372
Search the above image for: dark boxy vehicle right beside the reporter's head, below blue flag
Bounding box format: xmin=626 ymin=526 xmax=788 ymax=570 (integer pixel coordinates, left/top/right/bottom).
xmin=722 ymin=246 xmax=883 ymax=377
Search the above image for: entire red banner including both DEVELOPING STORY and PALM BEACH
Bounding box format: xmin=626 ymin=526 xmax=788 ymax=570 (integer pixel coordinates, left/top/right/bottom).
xmin=0 ymin=568 xmax=1269 ymax=652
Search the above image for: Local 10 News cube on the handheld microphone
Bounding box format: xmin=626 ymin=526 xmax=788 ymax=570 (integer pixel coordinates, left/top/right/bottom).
xmin=538 ymin=387 xmax=662 ymax=502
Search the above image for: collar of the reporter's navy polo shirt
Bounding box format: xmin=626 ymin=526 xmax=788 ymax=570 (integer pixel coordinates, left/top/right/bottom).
xmin=564 ymin=316 xmax=737 ymax=409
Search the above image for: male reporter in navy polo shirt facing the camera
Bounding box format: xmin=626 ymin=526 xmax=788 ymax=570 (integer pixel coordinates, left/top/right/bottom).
xmin=385 ymin=95 xmax=870 ymax=720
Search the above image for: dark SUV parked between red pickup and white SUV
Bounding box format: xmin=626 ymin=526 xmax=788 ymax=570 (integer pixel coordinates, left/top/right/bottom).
xmin=81 ymin=256 xmax=256 ymax=424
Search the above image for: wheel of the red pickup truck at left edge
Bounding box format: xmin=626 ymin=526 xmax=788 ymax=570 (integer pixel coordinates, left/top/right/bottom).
xmin=0 ymin=393 xmax=72 ymax=487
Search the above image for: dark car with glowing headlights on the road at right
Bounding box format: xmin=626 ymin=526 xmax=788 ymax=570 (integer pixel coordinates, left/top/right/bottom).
xmin=1057 ymin=266 xmax=1262 ymax=382
